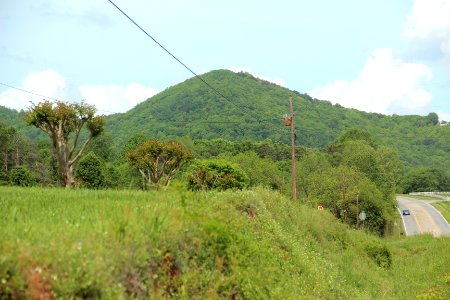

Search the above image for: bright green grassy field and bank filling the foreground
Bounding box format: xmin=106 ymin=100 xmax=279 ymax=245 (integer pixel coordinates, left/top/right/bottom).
xmin=0 ymin=187 xmax=450 ymax=299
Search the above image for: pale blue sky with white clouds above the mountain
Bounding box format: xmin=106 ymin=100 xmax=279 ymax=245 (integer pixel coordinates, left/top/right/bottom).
xmin=0 ymin=0 xmax=450 ymax=121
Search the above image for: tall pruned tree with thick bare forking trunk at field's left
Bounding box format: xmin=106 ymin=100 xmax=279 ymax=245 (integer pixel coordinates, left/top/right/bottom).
xmin=24 ymin=101 xmax=106 ymax=187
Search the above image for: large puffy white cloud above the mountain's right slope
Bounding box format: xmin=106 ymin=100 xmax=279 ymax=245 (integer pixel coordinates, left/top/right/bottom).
xmin=308 ymin=48 xmax=432 ymax=114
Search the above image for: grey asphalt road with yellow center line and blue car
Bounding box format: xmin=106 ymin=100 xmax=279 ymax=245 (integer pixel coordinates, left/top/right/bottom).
xmin=397 ymin=196 xmax=450 ymax=237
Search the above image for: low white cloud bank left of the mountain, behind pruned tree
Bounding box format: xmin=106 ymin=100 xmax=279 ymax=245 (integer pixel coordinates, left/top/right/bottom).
xmin=0 ymin=70 xmax=158 ymax=114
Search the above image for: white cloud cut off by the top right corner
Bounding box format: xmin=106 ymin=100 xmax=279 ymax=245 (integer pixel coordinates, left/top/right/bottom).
xmin=405 ymin=0 xmax=450 ymax=61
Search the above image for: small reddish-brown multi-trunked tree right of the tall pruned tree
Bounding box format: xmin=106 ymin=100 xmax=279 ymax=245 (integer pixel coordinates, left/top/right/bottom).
xmin=126 ymin=140 xmax=192 ymax=188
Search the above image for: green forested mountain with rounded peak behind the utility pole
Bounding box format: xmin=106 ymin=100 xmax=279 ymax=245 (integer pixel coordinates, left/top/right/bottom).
xmin=108 ymin=70 xmax=450 ymax=168
